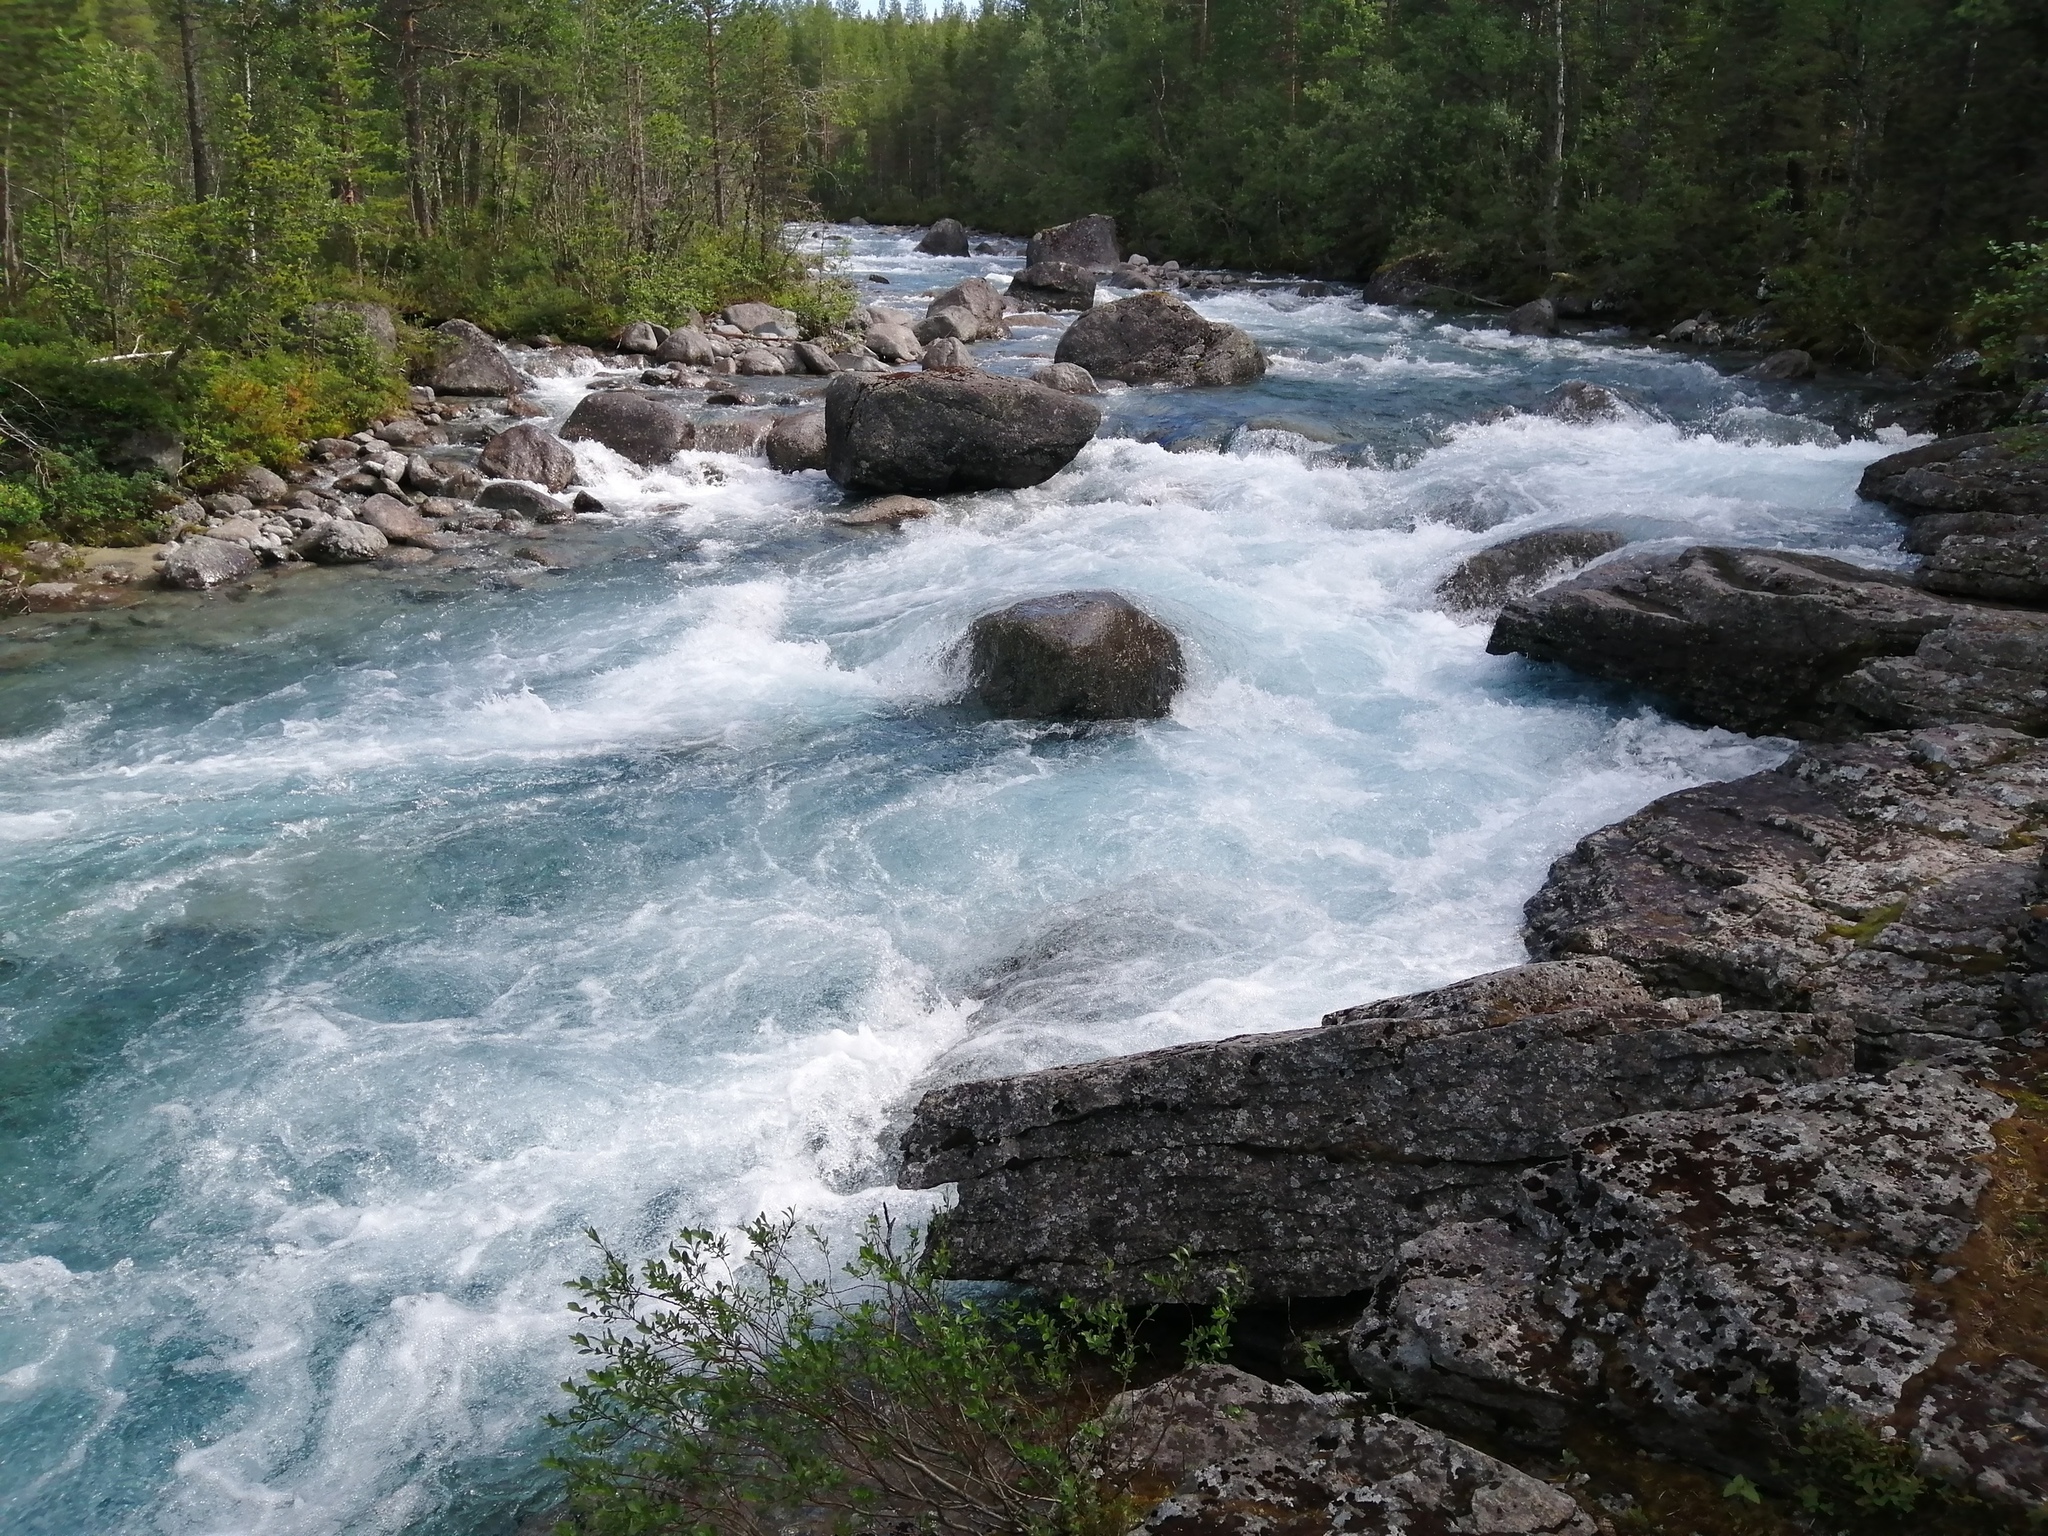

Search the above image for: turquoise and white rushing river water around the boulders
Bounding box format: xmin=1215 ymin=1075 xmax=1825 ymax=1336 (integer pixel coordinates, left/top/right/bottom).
xmin=0 ymin=229 xmax=1898 ymax=1536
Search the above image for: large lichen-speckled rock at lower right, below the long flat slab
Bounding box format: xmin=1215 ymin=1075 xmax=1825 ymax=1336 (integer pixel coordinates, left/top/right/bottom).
xmin=1350 ymin=1067 xmax=2011 ymax=1475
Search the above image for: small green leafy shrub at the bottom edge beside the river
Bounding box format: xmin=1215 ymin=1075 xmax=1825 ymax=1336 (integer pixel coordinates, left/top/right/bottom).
xmin=555 ymin=1217 xmax=1141 ymax=1536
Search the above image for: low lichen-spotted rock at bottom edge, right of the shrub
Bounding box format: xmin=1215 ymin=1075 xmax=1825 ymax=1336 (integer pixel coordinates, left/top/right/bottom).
xmin=1096 ymin=1366 xmax=1595 ymax=1536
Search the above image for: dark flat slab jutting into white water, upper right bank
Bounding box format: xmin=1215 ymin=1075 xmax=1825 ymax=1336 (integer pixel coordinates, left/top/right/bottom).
xmin=1487 ymin=545 xmax=2048 ymax=737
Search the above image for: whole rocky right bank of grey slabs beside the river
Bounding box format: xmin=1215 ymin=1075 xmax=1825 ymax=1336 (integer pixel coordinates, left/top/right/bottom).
xmin=901 ymin=385 xmax=2048 ymax=1532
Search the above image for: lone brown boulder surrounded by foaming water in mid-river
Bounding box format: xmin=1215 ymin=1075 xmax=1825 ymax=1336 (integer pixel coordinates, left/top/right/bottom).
xmin=967 ymin=592 xmax=1186 ymax=721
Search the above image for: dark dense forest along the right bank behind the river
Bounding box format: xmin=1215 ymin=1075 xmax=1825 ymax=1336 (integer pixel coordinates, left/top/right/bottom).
xmin=791 ymin=0 xmax=2048 ymax=365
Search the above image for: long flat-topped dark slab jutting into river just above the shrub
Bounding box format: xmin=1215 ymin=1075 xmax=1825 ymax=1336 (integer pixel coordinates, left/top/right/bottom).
xmin=903 ymin=961 xmax=1849 ymax=1300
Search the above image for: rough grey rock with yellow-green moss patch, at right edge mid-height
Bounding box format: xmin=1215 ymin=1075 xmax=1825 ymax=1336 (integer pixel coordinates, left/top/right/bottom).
xmin=1524 ymin=725 xmax=2048 ymax=1067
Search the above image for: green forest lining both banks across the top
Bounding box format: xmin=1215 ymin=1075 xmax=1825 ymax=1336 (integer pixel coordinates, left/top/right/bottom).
xmin=0 ymin=0 xmax=2048 ymax=541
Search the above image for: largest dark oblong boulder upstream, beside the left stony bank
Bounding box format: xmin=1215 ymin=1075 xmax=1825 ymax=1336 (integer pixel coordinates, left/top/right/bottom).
xmin=825 ymin=373 xmax=1102 ymax=496
